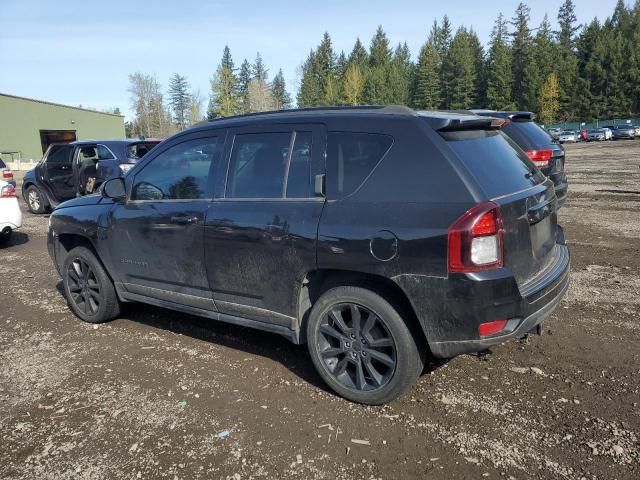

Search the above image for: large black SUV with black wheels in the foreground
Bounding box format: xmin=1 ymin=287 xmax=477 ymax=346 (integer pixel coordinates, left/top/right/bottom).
xmin=48 ymin=107 xmax=569 ymax=404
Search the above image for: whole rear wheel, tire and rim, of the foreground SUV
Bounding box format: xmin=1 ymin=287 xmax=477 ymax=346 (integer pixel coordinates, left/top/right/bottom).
xmin=307 ymin=286 xmax=424 ymax=405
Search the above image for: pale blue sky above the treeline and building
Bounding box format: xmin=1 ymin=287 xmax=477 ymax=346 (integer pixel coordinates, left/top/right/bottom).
xmin=0 ymin=0 xmax=616 ymax=120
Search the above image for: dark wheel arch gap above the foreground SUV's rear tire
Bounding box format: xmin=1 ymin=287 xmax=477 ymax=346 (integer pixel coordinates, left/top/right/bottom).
xmin=298 ymin=269 xmax=429 ymax=351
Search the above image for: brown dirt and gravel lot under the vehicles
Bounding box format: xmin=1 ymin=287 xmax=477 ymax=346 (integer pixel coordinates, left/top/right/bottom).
xmin=0 ymin=141 xmax=640 ymax=480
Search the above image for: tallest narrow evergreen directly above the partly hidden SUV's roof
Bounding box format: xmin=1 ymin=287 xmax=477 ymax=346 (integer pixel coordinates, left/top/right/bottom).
xmin=511 ymin=3 xmax=533 ymax=110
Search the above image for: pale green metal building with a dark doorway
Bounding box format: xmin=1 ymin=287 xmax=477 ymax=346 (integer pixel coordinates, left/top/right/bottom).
xmin=0 ymin=93 xmax=125 ymax=163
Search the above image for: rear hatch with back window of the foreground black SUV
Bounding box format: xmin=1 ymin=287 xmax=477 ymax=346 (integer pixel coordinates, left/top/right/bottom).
xmin=439 ymin=125 xmax=558 ymax=285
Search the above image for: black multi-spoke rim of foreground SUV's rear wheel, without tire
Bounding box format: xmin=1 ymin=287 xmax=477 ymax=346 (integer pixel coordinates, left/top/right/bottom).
xmin=318 ymin=303 xmax=397 ymax=392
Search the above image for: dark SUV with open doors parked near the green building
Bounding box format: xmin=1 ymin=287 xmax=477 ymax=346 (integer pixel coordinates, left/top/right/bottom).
xmin=22 ymin=139 xmax=160 ymax=213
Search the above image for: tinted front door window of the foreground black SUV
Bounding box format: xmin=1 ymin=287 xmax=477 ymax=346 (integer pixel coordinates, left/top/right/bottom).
xmin=131 ymin=137 xmax=221 ymax=200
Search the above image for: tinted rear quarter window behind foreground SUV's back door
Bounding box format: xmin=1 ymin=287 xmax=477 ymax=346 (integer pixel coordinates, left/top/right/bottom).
xmin=327 ymin=132 xmax=393 ymax=199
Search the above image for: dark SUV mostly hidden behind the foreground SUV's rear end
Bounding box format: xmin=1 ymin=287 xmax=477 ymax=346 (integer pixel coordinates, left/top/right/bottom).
xmin=471 ymin=110 xmax=568 ymax=207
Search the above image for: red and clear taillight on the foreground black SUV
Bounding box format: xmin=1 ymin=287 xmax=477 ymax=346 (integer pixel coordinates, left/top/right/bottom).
xmin=448 ymin=202 xmax=503 ymax=272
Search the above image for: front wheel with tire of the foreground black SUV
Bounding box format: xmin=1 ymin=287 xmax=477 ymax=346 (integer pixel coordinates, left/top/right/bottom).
xmin=62 ymin=247 xmax=120 ymax=323
